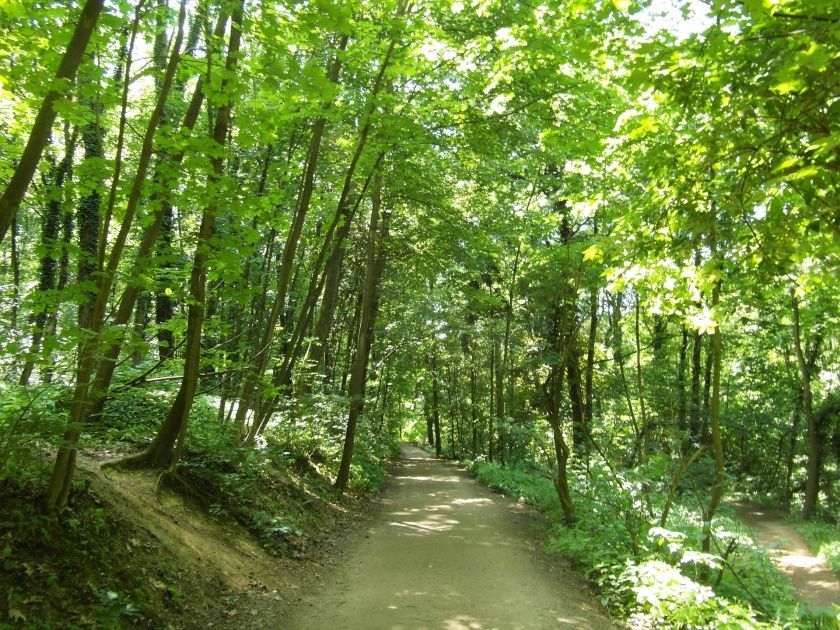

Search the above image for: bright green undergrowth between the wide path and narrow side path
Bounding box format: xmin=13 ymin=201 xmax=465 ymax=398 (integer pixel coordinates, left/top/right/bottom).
xmin=471 ymin=458 xmax=837 ymax=628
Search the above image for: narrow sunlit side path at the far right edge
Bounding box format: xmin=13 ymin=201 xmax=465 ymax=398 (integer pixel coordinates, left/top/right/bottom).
xmin=733 ymin=503 xmax=840 ymax=610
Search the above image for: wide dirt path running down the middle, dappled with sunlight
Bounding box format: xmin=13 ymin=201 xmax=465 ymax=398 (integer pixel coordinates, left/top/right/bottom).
xmin=281 ymin=447 xmax=612 ymax=630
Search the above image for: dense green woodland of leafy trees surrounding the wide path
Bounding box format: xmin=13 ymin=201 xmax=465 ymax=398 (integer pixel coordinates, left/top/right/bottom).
xmin=0 ymin=0 xmax=840 ymax=627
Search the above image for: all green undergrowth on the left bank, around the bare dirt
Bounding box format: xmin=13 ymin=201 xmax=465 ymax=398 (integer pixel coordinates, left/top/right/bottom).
xmin=0 ymin=382 xmax=395 ymax=628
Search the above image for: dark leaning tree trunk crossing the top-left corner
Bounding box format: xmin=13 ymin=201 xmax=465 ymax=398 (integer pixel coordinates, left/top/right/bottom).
xmin=0 ymin=0 xmax=105 ymax=242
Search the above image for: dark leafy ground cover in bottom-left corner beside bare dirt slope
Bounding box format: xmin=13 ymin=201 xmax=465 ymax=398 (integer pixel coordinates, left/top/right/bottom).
xmin=0 ymin=469 xmax=171 ymax=629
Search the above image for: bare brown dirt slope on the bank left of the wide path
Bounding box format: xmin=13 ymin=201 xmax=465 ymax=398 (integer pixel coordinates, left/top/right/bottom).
xmin=79 ymin=456 xmax=357 ymax=630
